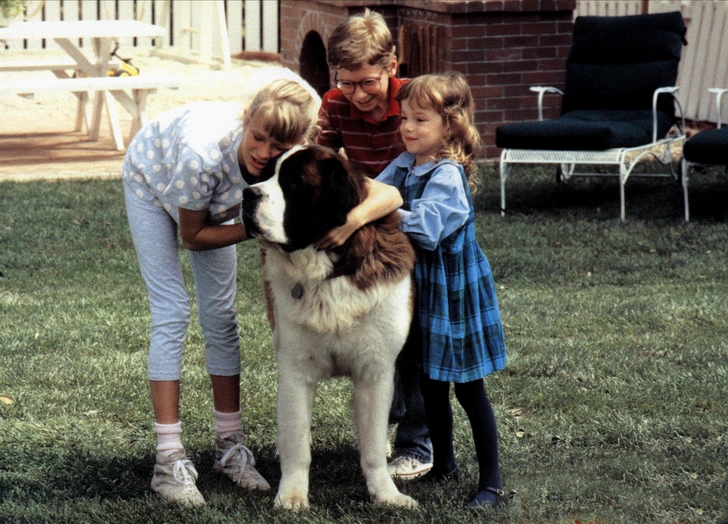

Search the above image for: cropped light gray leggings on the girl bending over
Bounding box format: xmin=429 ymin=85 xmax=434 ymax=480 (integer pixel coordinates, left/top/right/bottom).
xmin=124 ymin=183 xmax=240 ymax=380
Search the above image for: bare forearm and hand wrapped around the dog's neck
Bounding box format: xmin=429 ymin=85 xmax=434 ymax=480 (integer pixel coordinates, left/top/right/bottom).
xmin=315 ymin=178 xmax=403 ymax=249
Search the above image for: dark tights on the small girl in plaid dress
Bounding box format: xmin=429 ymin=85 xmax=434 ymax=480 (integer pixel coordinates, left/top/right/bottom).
xmin=420 ymin=375 xmax=503 ymax=491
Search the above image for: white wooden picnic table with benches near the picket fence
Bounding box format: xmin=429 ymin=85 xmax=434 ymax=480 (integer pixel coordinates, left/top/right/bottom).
xmin=0 ymin=20 xmax=180 ymax=151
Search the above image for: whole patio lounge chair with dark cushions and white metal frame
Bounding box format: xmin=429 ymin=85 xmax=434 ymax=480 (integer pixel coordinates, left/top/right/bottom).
xmin=496 ymin=11 xmax=687 ymax=220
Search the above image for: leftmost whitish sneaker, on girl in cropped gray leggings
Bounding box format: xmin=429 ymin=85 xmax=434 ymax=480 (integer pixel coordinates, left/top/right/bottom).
xmin=150 ymin=450 xmax=205 ymax=508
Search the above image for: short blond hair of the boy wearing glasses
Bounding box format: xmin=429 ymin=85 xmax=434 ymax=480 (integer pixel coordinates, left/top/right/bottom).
xmin=326 ymin=9 xmax=396 ymax=71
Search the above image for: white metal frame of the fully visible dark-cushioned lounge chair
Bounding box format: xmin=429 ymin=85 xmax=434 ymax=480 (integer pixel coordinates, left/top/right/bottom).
xmin=500 ymin=86 xmax=687 ymax=221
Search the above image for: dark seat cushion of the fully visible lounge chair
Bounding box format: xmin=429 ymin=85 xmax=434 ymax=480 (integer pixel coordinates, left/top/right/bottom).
xmin=495 ymin=110 xmax=673 ymax=151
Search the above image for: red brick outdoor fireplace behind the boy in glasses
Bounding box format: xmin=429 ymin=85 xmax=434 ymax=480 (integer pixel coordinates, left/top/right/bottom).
xmin=280 ymin=0 xmax=576 ymax=158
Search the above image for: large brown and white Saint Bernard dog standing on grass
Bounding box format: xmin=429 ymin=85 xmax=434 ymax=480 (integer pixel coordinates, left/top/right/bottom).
xmin=242 ymin=146 xmax=416 ymax=511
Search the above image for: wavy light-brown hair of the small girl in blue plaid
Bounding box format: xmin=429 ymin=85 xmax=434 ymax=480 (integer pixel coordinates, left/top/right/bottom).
xmin=396 ymin=72 xmax=480 ymax=193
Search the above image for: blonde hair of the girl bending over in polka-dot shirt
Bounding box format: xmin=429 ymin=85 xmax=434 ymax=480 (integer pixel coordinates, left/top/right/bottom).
xmin=243 ymin=78 xmax=319 ymax=144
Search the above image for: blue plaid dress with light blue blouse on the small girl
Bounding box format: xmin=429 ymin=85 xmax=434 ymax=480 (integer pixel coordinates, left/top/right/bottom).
xmin=377 ymin=152 xmax=506 ymax=382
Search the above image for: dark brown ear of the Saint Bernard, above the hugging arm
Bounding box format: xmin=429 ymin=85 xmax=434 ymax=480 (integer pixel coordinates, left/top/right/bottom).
xmin=319 ymin=154 xmax=362 ymax=225
